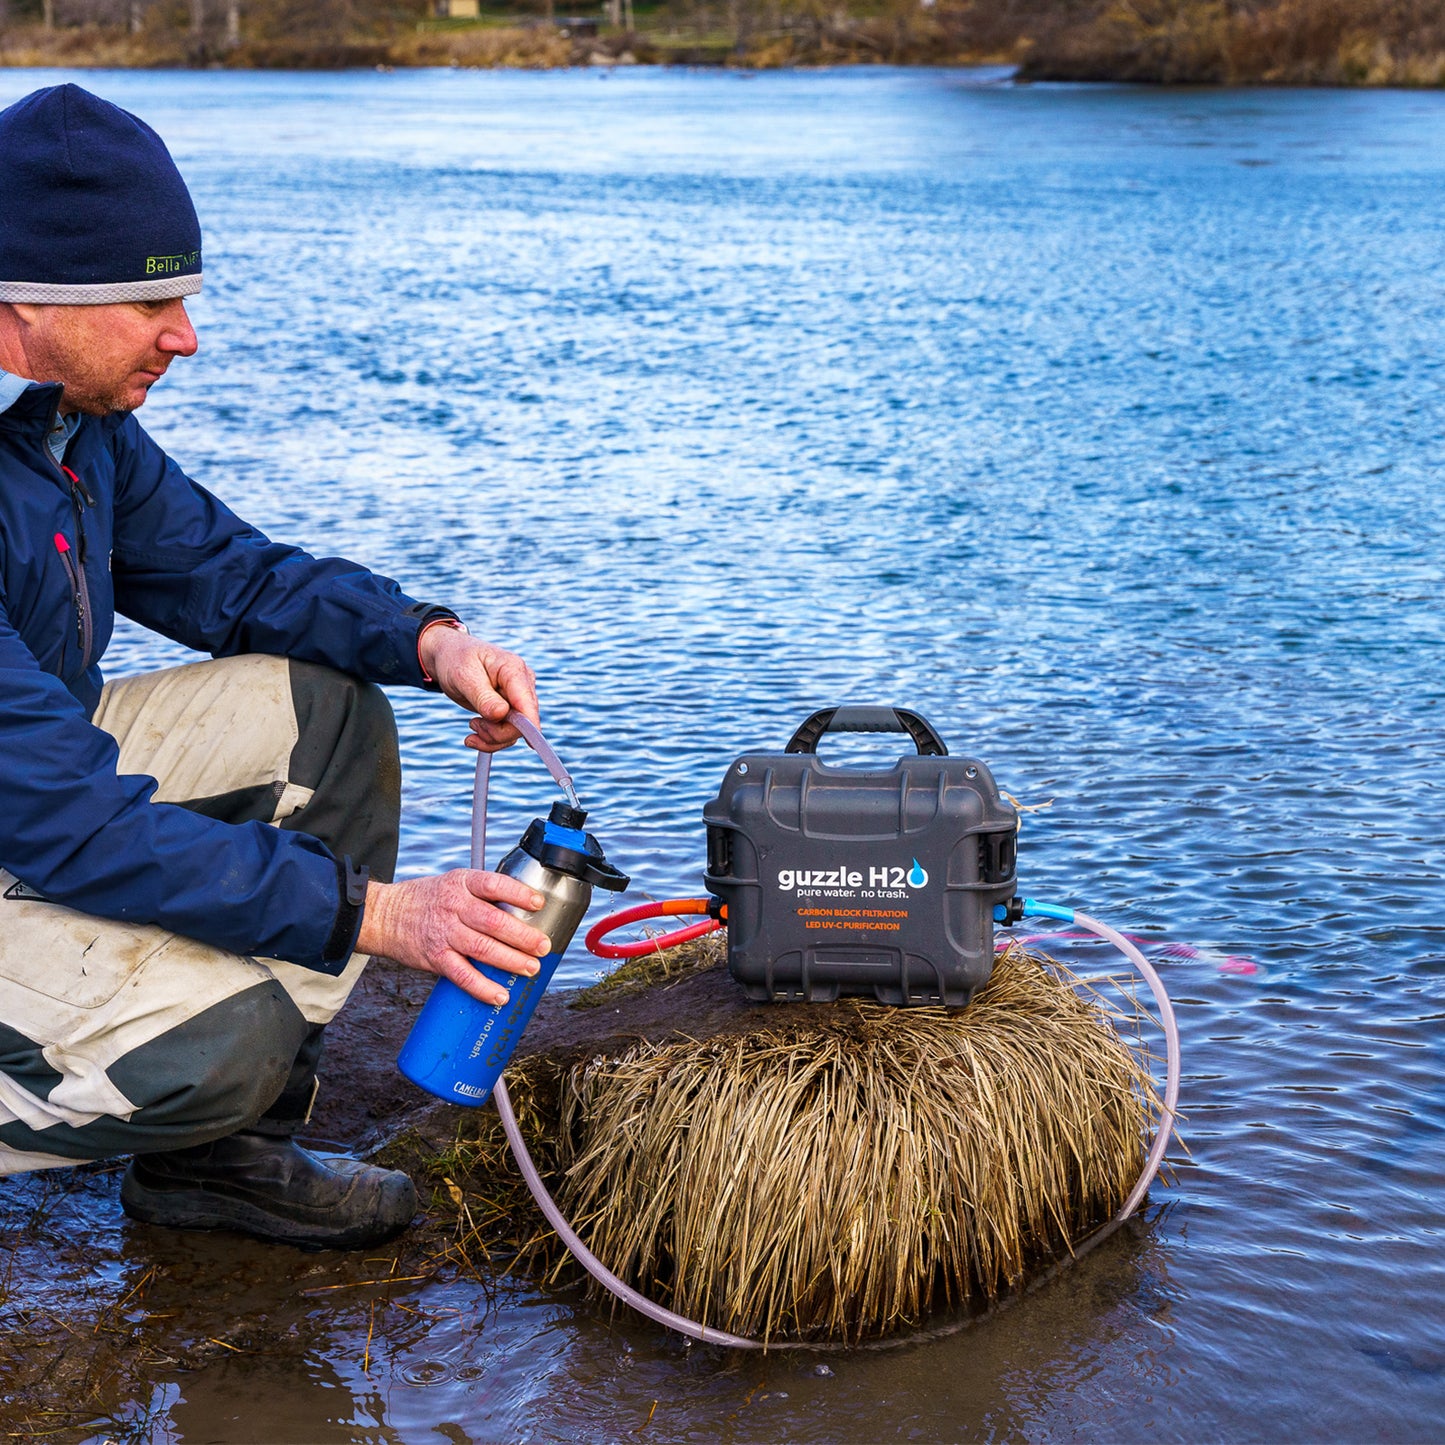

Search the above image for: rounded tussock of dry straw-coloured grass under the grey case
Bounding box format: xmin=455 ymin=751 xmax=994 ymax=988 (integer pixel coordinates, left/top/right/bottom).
xmin=421 ymin=948 xmax=1159 ymax=1341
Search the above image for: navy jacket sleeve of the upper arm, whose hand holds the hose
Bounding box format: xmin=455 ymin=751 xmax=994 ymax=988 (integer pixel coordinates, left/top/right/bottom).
xmin=111 ymin=418 xmax=455 ymax=686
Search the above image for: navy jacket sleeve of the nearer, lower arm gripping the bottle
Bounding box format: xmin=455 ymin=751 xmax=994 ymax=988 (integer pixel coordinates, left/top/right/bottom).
xmin=0 ymin=597 xmax=360 ymax=972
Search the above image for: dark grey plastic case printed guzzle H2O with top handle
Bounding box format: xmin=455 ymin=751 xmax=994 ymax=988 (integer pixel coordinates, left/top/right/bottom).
xmin=702 ymin=708 xmax=1019 ymax=1007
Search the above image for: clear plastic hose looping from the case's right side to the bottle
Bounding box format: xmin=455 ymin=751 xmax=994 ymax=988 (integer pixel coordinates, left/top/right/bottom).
xmin=471 ymin=712 xmax=1181 ymax=1350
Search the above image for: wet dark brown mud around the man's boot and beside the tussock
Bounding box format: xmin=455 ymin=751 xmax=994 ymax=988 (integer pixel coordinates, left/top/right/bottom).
xmin=0 ymin=958 xmax=768 ymax=1441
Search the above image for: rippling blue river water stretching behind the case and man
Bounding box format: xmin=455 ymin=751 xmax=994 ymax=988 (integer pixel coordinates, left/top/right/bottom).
xmin=0 ymin=71 xmax=1445 ymax=1442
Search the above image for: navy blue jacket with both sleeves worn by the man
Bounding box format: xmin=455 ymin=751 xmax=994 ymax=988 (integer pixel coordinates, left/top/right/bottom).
xmin=0 ymin=386 xmax=451 ymax=972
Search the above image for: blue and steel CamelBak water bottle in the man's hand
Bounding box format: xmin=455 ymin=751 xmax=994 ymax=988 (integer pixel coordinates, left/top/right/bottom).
xmin=396 ymin=802 xmax=629 ymax=1105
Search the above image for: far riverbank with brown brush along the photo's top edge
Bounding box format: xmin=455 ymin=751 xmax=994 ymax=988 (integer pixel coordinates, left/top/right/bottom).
xmin=8 ymin=0 xmax=1445 ymax=88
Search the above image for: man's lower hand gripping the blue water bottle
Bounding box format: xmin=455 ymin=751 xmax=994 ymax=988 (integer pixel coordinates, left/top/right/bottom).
xmin=357 ymin=867 xmax=552 ymax=1004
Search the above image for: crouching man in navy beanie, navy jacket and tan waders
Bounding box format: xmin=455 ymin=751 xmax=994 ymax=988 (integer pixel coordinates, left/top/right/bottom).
xmin=0 ymin=85 xmax=549 ymax=1247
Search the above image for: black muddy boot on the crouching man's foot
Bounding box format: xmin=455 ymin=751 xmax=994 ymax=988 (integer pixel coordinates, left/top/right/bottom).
xmin=120 ymin=1129 xmax=416 ymax=1250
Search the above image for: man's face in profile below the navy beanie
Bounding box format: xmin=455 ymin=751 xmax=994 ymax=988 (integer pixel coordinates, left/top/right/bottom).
xmin=14 ymin=296 xmax=197 ymax=416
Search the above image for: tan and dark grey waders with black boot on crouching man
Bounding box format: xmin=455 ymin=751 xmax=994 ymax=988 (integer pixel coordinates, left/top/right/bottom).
xmin=0 ymin=656 xmax=415 ymax=1247
